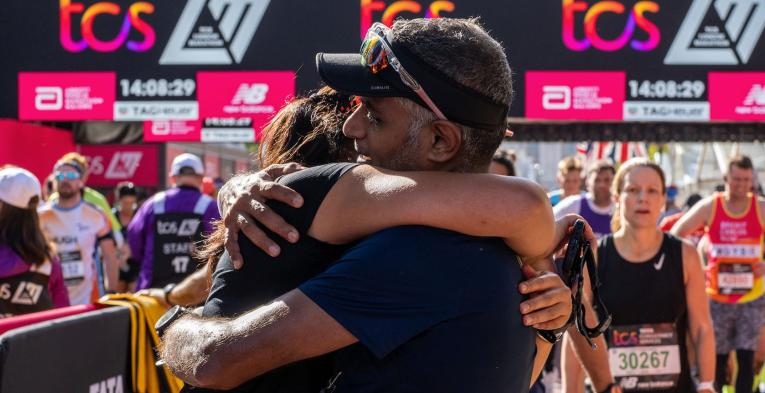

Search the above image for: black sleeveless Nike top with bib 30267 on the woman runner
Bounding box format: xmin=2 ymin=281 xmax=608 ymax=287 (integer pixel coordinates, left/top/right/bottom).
xmin=598 ymin=234 xmax=694 ymax=393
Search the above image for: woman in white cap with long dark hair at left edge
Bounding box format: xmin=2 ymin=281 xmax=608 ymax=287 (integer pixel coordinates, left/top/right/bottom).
xmin=0 ymin=167 xmax=69 ymax=318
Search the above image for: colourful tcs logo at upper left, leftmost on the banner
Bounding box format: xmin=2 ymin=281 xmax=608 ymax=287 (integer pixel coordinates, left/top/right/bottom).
xmin=59 ymin=0 xmax=156 ymax=53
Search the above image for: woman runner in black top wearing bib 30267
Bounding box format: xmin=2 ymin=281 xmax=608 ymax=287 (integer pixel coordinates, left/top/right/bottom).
xmin=579 ymin=158 xmax=715 ymax=393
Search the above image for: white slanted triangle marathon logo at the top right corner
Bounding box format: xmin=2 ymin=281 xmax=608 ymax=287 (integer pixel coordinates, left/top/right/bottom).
xmin=664 ymin=0 xmax=765 ymax=65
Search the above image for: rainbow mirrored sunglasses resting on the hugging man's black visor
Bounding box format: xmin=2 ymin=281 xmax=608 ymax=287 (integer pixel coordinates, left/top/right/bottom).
xmin=360 ymin=22 xmax=447 ymax=120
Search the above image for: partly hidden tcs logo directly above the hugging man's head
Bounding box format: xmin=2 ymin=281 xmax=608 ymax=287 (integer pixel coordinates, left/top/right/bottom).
xmin=361 ymin=0 xmax=454 ymax=39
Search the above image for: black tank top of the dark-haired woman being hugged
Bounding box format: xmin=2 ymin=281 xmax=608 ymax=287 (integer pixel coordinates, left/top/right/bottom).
xmin=188 ymin=163 xmax=358 ymax=393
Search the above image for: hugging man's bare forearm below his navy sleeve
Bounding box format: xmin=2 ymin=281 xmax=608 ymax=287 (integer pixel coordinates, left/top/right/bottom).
xmin=160 ymin=289 xmax=358 ymax=390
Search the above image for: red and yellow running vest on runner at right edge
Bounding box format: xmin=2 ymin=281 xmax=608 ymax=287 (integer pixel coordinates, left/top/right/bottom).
xmin=706 ymin=193 xmax=765 ymax=303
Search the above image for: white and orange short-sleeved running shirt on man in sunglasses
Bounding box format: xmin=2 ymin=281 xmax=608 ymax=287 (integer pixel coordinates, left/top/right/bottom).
xmin=38 ymin=201 xmax=111 ymax=305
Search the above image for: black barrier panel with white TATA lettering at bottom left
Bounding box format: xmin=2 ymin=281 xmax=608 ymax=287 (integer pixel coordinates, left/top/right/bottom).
xmin=0 ymin=307 xmax=131 ymax=393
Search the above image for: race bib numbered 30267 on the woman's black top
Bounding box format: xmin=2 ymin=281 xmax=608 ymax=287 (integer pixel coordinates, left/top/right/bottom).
xmin=608 ymin=323 xmax=681 ymax=390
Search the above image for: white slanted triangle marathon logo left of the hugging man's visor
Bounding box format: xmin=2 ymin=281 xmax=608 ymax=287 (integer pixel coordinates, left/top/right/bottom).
xmin=159 ymin=0 xmax=271 ymax=64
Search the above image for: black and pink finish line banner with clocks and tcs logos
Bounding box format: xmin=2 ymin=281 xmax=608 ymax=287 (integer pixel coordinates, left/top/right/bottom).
xmin=0 ymin=0 xmax=765 ymax=122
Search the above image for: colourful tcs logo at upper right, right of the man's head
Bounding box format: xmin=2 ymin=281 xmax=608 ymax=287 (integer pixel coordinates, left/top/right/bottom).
xmin=563 ymin=0 xmax=661 ymax=52
